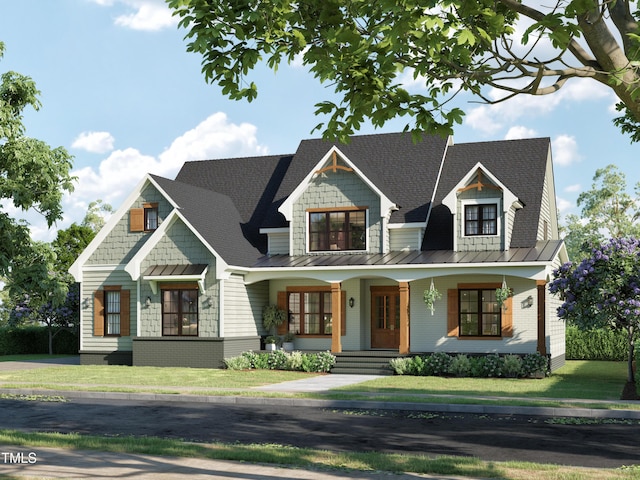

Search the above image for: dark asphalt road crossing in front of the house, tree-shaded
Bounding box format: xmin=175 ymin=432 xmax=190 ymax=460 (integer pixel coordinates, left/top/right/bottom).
xmin=0 ymin=399 xmax=640 ymax=468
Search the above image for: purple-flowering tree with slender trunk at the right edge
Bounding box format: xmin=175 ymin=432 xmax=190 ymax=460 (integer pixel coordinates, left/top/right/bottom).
xmin=549 ymin=238 xmax=640 ymax=400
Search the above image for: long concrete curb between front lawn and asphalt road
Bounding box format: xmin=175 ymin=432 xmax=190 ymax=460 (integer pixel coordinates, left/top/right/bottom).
xmin=5 ymin=388 xmax=640 ymax=420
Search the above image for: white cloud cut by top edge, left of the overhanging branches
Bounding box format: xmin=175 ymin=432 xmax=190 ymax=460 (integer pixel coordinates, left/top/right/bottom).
xmin=92 ymin=0 xmax=178 ymax=32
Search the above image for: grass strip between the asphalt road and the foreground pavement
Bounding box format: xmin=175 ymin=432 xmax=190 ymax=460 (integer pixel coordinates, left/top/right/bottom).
xmin=0 ymin=430 xmax=640 ymax=480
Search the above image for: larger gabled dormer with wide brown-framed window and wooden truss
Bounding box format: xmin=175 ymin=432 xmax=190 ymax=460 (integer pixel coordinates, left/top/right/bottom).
xmin=278 ymin=146 xmax=397 ymax=255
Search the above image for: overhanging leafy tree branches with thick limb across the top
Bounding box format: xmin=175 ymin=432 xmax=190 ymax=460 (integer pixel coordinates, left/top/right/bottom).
xmin=167 ymin=0 xmax=640 ymax=141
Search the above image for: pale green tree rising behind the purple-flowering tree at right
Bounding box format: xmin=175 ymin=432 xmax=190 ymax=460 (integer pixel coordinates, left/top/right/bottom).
xmin=565 ymin=165 xmax=640 ymax=262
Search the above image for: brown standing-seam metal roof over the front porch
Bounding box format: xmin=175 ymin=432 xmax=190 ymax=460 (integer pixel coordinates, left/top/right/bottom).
xmin=253 ymin=240 xmax=563 ymax=268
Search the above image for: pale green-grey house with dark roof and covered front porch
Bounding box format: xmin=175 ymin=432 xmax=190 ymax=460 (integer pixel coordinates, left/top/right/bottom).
xmin=70 ymin=133 xmax=567 ymax=368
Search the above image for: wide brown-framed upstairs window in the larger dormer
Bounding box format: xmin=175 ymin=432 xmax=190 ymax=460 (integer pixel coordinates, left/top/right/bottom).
xmin=309 ymin=210 xmax=367 ymax=252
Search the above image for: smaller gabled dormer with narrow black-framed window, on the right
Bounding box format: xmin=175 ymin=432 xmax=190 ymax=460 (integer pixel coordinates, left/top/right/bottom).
xmin=442 ymin=162 xmax=523 ymax=252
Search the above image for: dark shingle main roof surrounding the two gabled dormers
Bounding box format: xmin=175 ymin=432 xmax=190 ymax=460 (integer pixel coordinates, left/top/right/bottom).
xmin=164 ymin=133 xmax=549 ymax=266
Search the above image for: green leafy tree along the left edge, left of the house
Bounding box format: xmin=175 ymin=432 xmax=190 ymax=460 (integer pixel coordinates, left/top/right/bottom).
xmin=0 ymin=42 xmax=74 ymax=292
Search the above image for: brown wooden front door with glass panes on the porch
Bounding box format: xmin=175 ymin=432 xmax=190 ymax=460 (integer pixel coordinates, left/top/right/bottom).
xmin=371 ymin=287 xmax=400 ymax=349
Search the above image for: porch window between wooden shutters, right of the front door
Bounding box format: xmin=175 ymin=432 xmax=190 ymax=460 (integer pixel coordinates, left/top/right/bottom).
xmin=458 ymin=289 xmax=502 ymax=337
